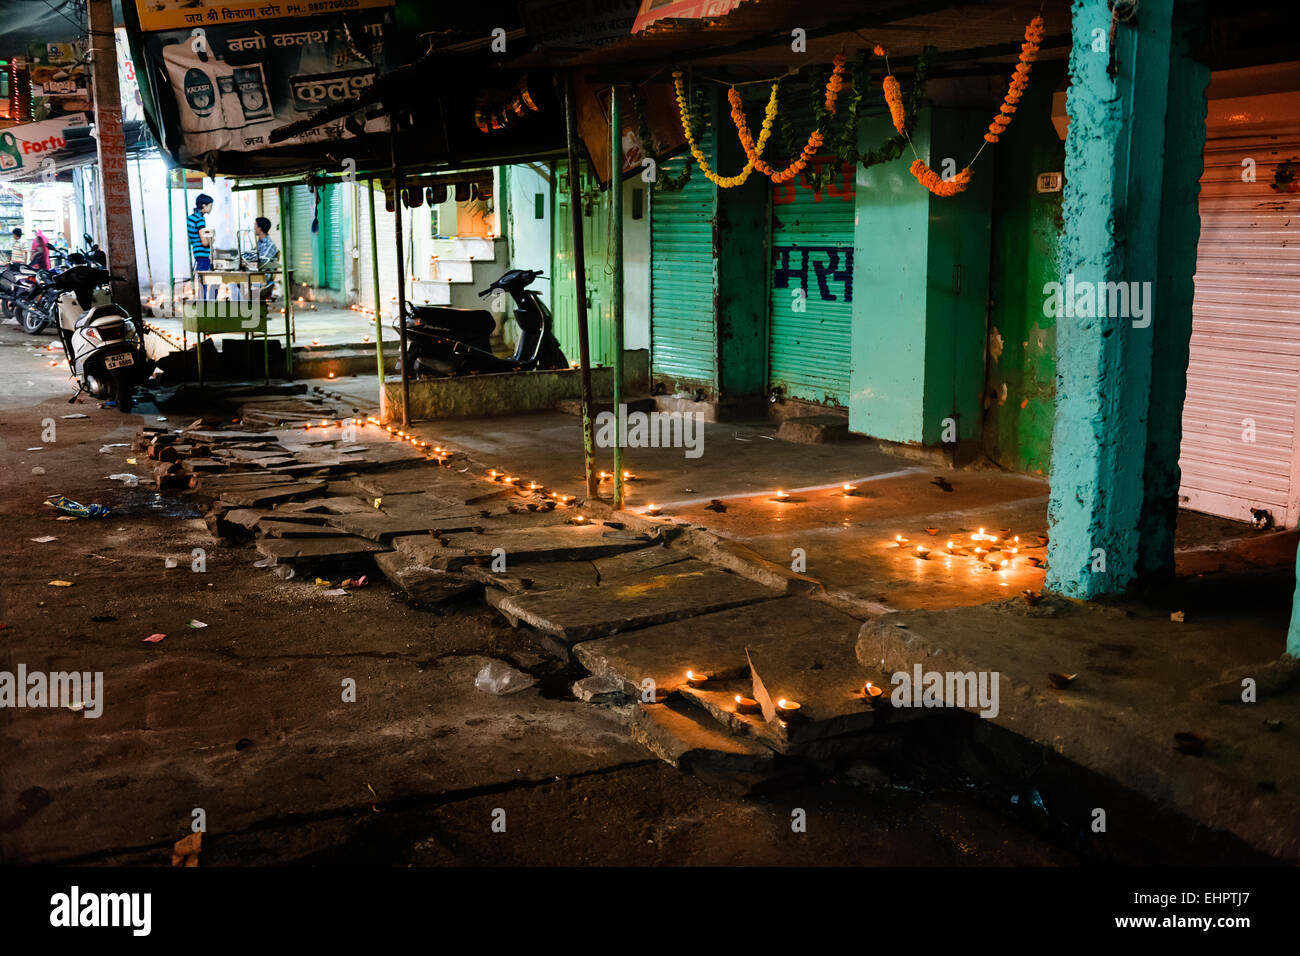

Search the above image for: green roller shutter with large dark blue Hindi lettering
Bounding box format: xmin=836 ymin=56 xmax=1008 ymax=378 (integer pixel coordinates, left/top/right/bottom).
xmin=768 ymin=133 xmax=854 ymax=406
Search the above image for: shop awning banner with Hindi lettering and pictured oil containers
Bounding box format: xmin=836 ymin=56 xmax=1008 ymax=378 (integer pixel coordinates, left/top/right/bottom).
xmin=139 ymin=0 xmax=393 ymax=161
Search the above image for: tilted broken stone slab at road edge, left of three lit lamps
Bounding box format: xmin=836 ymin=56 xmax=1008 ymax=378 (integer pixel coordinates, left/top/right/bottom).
xmin=632 ymin=701 xmax=776 ymax=774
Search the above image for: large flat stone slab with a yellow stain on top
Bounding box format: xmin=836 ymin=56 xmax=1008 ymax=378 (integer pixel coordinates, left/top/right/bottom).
xmin=501 ymin=561 xmax=777 ymax=650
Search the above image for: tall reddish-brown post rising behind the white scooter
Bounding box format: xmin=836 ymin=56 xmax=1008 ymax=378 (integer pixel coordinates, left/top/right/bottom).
xmin=87 ymin=0 xmax=140 ymax=317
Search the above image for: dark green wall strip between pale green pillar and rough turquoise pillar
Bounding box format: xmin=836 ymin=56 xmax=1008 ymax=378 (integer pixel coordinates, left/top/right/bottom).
xmin=984 ymin=62 xmax=1065 ymax=475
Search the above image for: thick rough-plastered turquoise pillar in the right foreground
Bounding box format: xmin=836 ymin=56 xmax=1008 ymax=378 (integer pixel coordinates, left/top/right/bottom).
xmin=1031 ymin=0 xmax=1209 ymax=598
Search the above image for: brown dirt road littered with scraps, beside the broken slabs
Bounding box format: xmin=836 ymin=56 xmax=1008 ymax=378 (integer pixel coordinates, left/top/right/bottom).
xmin=0 ymin=324 xmax=1076 ymax=865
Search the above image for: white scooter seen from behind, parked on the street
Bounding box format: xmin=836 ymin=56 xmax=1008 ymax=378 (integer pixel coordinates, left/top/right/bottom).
xmin=43 ymin=265 xmax=150 ymax=412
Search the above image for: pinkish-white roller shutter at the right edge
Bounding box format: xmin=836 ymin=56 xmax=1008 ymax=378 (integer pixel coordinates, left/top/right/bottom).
xmin=1179 ymin=129 xmax=1300 ymax=527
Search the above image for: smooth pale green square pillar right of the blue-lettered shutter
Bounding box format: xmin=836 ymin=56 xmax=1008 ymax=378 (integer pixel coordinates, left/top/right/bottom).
xmin=849 ymin=109 xmax=992 ymax=445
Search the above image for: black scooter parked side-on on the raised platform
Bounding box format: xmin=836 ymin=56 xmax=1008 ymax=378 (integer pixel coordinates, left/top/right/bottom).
xmin=393 ymin=269 xmax=568 ymax=377
